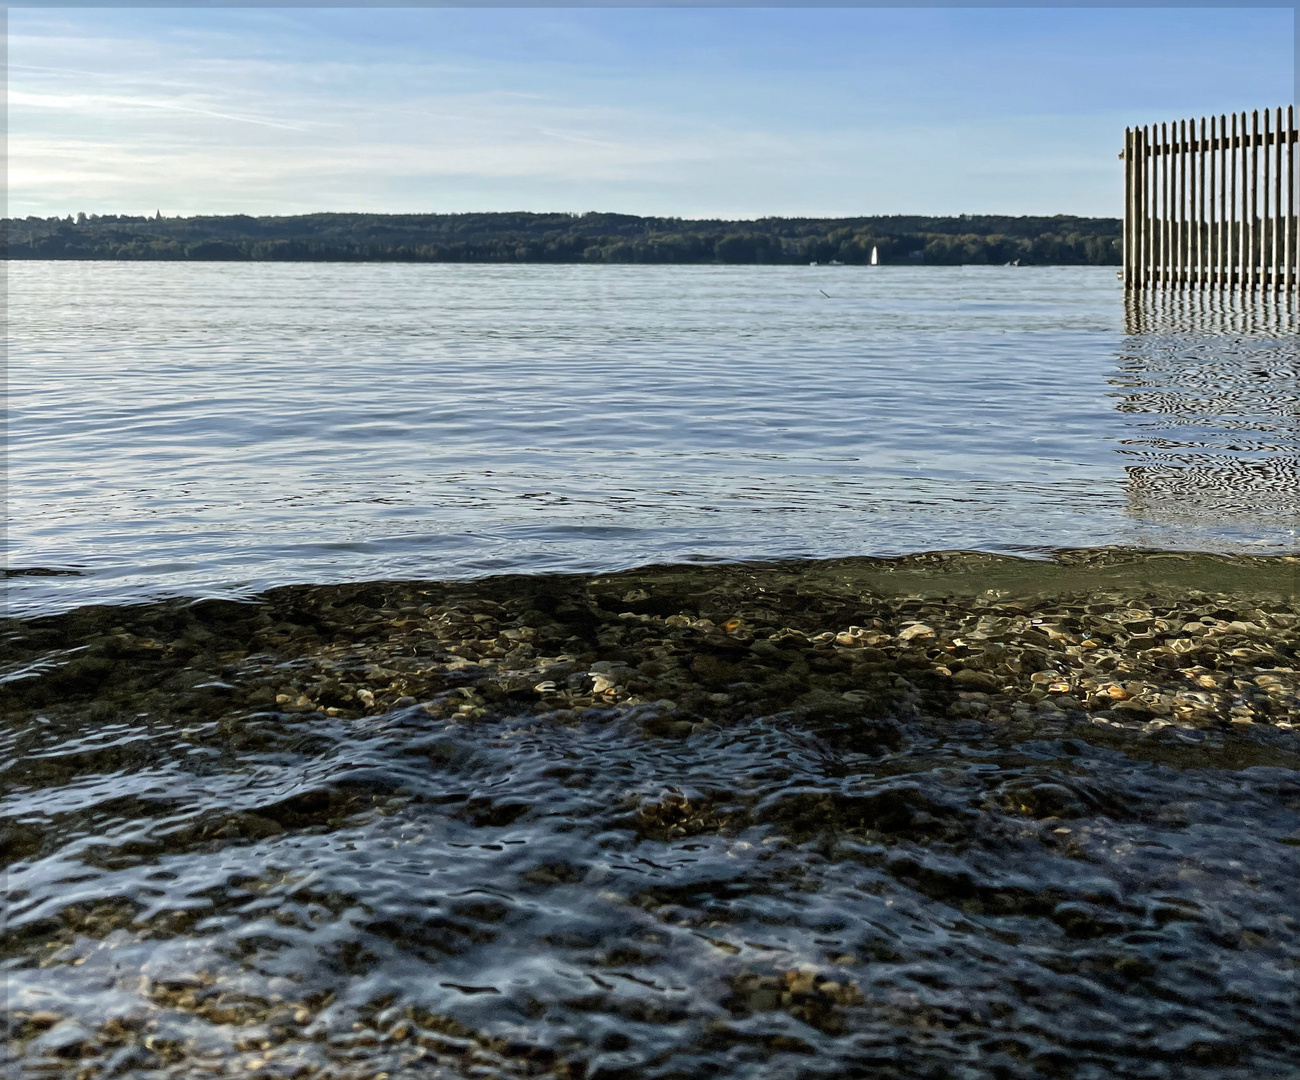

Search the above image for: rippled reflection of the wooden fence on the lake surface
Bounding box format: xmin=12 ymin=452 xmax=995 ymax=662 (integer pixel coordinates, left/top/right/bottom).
xmin=1112 ymin=294 xmax=1300 ymax=529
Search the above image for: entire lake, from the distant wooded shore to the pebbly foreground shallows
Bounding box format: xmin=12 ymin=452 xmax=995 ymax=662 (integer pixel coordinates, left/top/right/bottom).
xmin=10 ymin=263 xmax=1300 ymax=1080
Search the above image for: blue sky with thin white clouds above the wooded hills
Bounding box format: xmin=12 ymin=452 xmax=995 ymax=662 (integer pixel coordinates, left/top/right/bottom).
xmin=8 ymin=6 xmax=1296 ymax=218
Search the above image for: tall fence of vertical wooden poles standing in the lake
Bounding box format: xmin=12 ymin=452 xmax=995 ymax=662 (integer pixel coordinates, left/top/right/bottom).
xmin=1121 ymin=105 xmax=1300 ymax=294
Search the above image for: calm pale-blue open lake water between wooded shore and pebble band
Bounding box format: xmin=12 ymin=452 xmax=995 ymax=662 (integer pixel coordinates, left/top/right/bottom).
xmin=8 ymin=263 xmax=1300 ymax=612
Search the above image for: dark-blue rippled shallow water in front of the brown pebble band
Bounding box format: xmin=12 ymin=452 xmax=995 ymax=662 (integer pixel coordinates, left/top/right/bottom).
xmin=9 ymin=710 xmax=1300 ymax=1080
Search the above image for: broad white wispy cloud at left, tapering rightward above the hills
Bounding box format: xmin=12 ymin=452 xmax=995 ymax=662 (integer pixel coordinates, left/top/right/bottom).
xmin=9 ymin=19 xmax=797 ymax=212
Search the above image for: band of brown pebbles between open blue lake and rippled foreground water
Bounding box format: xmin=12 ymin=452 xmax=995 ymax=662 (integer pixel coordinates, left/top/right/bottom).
xmin=4 ymin=551 xmax=1300 ymax=753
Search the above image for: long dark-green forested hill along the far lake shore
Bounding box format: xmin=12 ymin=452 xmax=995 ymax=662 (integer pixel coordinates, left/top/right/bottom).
xmin=3 ymin=213 xmax=1121 ymax=265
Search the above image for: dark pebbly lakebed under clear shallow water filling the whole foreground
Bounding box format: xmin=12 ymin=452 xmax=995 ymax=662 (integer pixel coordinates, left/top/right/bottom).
xmin=0 ymin=550 xmax=1300 ymax=1080
